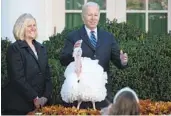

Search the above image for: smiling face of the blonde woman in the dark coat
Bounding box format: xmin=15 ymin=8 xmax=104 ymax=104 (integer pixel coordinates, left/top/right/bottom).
xmin=25 ymin=19 xmax=37 ymax=40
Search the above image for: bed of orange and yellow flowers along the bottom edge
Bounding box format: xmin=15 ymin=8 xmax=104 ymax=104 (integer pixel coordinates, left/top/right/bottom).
xmin=29 ymin=100 xmax=171 ymax=115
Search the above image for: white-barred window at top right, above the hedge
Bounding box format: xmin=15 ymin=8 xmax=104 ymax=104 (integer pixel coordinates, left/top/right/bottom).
xmin=126 ymin=0 xmax=169 ymax=34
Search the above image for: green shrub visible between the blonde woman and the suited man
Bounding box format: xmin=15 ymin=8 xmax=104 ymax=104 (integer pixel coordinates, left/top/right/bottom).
xmin=43 ymin=27 xmax=79 ymax=104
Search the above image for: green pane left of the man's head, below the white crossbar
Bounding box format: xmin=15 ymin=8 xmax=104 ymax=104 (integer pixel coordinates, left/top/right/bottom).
xmin=65 ymin=13 xmax=83 ymax=29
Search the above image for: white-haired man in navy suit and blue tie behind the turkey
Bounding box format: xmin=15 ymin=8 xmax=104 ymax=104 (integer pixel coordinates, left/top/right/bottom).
xmin=60 ymin=2 xmax=128 ymax=108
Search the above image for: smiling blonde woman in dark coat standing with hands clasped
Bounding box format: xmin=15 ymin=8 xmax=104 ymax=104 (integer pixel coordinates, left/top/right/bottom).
xmin=2 ymin=13 xmax=52 ymax=115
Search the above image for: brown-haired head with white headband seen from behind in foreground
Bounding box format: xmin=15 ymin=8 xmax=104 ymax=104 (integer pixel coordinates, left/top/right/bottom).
xmin=109 ymin=87 xmax=140 ymax=115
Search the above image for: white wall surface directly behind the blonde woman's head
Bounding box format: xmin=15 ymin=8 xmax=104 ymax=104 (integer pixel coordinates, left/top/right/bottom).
xmin=1 ymin=0 xmax=53 ymax=42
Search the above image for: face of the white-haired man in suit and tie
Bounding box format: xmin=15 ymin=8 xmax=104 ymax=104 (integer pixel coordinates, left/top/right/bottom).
xmin=83 ymin=6 xmax=100 ymax=30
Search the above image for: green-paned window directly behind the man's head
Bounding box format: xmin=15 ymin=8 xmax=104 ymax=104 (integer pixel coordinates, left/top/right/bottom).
xmin=65 ymin=0 xmax=106 ymax=29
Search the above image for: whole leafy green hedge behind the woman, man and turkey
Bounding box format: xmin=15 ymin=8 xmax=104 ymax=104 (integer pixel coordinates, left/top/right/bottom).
xmin=1 ymin=20 xmax=171 ymax=104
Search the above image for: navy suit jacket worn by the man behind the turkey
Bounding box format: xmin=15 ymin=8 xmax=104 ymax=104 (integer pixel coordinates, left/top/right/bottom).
xmin=60 ymin=25 xmax=124 ymax=105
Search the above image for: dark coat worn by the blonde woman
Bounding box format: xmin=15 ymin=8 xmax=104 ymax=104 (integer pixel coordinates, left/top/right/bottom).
xmin=2 ymin=40 xmax=52 ymax=112
